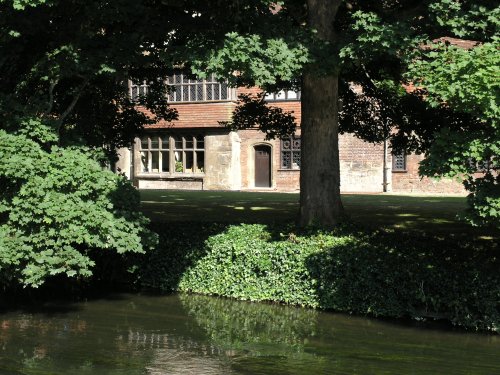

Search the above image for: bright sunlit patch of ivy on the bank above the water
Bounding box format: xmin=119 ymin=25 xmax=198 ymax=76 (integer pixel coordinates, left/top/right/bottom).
xmin=179 ymin=225 xmax=331 ymax=307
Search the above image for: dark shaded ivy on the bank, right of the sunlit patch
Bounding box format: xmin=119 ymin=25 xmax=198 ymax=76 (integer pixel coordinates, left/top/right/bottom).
xmin=306 ymin=231 xmax=500 ymax=329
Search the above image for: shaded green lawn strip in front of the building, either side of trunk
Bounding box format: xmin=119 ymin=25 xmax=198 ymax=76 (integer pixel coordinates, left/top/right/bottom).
xmin=140 ymin=190 xmax=498 ymax=238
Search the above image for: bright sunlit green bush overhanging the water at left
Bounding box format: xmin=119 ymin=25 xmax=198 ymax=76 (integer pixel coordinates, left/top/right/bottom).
xmin=0 ymin=119 xmax=156 ymax=287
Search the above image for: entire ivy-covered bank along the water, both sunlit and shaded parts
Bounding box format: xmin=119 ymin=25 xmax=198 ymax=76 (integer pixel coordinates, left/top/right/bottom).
xmin=138 ymin=223 xmax=500 ymax=331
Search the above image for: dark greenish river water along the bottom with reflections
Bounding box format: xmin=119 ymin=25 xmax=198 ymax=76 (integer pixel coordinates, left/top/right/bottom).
xmin=0 ymin=294 xmax=500 ymax=375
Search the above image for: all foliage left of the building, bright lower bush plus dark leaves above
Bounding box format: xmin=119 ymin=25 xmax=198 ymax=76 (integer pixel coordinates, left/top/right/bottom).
xmin=0 ymin=0 xmax=183 ymax=286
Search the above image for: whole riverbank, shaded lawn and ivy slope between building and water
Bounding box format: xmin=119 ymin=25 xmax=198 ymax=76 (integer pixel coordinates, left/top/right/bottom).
xmin=0 ymin=191 xmax=500 ymax=332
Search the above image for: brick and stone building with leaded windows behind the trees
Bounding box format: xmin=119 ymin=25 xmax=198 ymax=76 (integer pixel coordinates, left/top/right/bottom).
xmin=117 ymin=74 xmax=464 ymax=193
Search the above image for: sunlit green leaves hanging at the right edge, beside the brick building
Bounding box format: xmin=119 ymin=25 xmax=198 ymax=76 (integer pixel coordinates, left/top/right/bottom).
xmin=408 ymin=39 xmax=500 ymax=226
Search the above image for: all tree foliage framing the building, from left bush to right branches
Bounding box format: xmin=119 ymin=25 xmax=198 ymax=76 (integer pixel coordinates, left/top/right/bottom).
xmin=0 ymin=0 xmax=500 ymax=285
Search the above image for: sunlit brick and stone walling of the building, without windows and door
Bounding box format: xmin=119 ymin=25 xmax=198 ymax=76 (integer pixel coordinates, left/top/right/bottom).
xmin=128 ymin=88 xmax=465 ymax=193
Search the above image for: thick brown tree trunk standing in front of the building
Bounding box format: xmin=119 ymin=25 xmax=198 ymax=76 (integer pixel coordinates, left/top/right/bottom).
xmin=299 ymin=0 xmax=344 ymax=227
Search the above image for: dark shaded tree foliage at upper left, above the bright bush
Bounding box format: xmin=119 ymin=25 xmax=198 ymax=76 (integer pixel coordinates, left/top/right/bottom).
xmin=0 ymin=0 xmax=176 ymax=154
